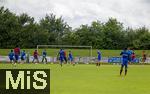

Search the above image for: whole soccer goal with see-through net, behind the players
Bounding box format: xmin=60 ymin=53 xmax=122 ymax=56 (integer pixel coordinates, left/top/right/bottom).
xmin=37 ymin=45 xmax=92 ymax=63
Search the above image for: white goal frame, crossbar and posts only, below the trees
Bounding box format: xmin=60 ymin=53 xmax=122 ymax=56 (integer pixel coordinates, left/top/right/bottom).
xmin=37 ymin=45 xmax=92 ymax=58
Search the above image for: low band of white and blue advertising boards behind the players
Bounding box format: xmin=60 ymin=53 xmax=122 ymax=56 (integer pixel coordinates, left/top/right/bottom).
xmin=0 ymin=56 xmax=150 ymax=64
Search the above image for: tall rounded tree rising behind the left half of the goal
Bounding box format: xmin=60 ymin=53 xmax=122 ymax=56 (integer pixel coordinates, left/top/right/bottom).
xmin=40 ymin=14 xmax=70 ymax=44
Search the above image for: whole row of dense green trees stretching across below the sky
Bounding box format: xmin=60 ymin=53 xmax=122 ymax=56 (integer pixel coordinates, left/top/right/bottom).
xmin=0 ymin=7 xmax=150 ymax=49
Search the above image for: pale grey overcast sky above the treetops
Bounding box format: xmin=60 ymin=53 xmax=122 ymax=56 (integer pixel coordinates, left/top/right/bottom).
xmin=0 ymin=0 xmax=150 ymax=28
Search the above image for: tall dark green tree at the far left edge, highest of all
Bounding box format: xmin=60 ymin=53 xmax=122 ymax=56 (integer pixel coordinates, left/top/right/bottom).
xmin=0 ymin=7 xmax=18 ymax=48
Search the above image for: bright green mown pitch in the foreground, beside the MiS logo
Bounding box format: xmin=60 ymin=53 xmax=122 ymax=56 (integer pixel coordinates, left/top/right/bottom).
xmin=0 ymin=64 xmax=150 ymax=94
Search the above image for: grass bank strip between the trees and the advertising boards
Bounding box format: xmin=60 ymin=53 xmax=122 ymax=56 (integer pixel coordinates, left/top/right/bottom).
xmin=0 ymin=49 xmax=150 ymax=57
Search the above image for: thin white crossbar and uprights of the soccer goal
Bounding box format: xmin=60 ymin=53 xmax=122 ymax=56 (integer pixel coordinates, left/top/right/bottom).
xmin=37 ymin=45 xmax=93 ymax=58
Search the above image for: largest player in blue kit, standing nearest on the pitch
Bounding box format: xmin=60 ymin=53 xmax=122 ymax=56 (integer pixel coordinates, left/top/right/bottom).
xmin=120 ymin=48 xmax=130 ymax=75
